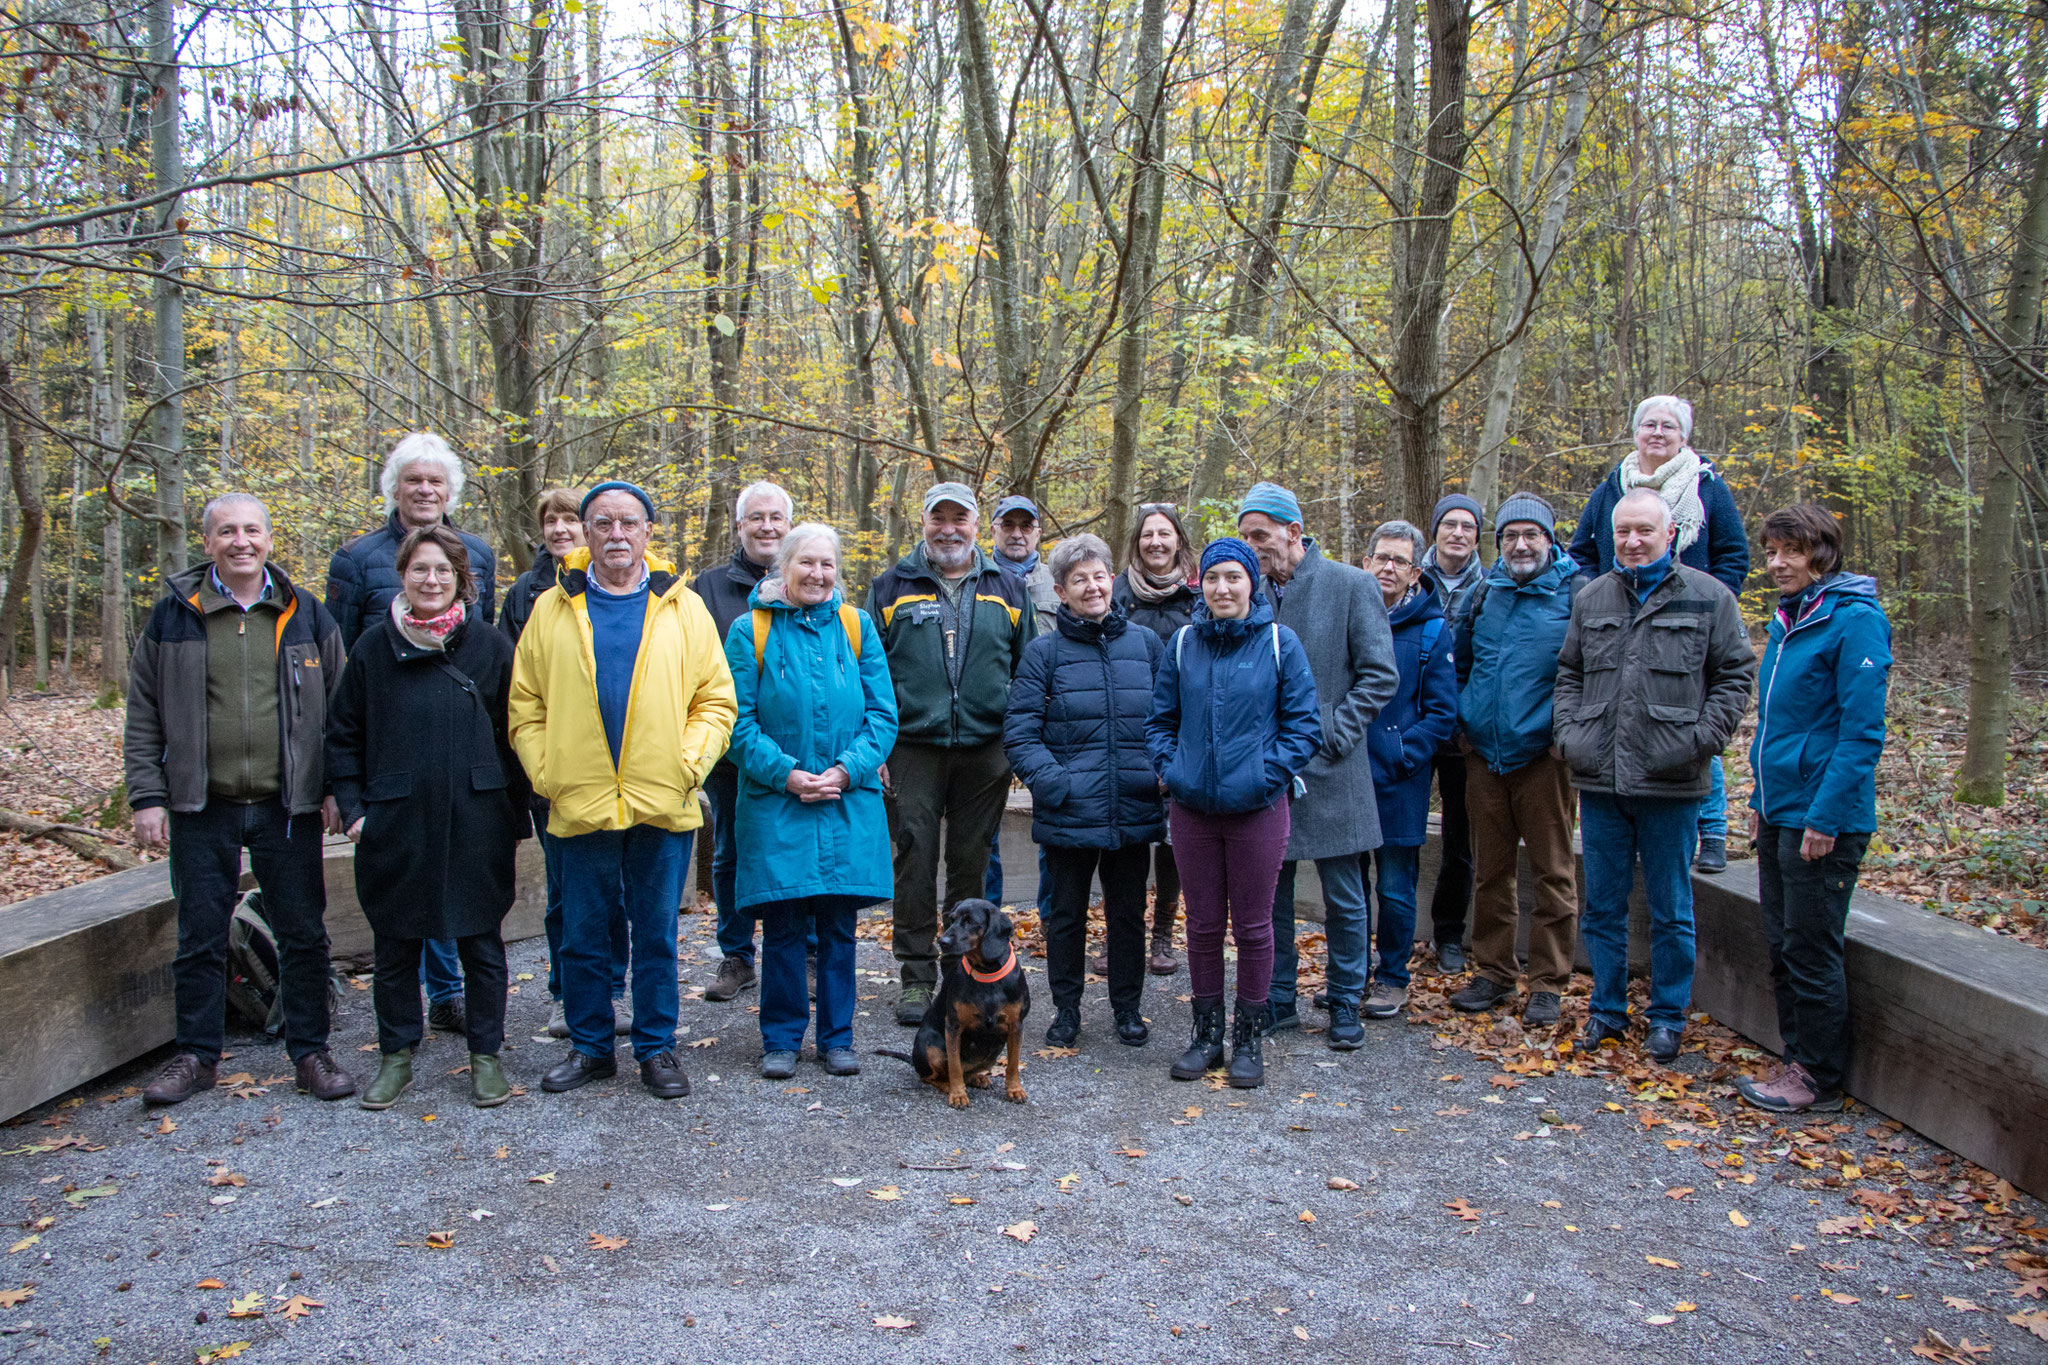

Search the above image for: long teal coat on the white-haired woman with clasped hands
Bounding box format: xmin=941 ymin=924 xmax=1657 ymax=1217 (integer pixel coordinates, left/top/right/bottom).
xmin=725 ymin=579 xmax=897 ymax=909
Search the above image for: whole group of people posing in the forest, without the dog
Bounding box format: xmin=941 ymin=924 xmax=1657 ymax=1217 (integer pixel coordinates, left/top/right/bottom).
xmin=127 ymin=395 xmax=1890 ymax=1111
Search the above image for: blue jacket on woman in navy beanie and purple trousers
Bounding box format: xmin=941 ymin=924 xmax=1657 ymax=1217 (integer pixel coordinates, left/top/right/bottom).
xmin=1145 ymin=591 xmax=1323 ymax=814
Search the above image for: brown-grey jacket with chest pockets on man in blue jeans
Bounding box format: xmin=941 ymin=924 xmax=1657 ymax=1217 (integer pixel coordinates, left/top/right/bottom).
xmin=1552 ymin=565 xmax=1757 ymax=800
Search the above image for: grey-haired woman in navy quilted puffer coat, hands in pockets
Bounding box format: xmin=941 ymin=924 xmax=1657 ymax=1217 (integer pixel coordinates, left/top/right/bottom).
xmin=1004 ymin=534 xmax=1165 ymax=1048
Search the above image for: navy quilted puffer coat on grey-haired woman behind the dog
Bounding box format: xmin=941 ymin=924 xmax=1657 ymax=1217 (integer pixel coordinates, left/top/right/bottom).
xmin=1004 ymin=608 xmax=1165 ymax=849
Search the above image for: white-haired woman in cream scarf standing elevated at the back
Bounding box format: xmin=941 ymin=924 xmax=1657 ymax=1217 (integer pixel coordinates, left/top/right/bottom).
xmin=1571 ymin=393 xmax=1749 ymax=872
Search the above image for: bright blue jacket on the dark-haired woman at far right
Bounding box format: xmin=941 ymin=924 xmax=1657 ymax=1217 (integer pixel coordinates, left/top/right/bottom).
xmin=1749 ymin=573 xmax=1892 ymax=835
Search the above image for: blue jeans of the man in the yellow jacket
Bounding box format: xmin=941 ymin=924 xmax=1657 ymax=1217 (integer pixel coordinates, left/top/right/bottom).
xmin=555 ymin=825 xmax=690 ymax=1062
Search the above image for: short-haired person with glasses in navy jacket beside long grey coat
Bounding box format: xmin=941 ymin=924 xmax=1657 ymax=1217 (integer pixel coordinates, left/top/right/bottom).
xmin=1358 ymin=522 xmax=1458 ymax=1019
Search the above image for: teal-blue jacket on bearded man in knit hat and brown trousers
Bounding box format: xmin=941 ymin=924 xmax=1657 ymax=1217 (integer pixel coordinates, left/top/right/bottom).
xmin=1452 ymin=548 xmax=1579 ymax=774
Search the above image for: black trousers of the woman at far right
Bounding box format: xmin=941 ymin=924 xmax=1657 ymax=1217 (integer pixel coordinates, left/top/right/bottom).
xmin=1757 ymin=825 xmax=1870 ymax=1093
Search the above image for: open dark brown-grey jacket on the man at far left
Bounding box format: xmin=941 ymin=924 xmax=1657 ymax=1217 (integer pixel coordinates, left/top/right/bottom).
xmin=121 ymin=563 xmax=342 ymax=814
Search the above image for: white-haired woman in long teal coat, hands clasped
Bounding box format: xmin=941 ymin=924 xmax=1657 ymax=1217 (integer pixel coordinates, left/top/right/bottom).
xmin=725 ymin=522 xmax=897 ymax=1081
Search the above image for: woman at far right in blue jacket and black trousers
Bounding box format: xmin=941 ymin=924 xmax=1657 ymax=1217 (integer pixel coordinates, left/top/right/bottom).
xmin=1735 ymin=503 xmax=1892 ymax=1113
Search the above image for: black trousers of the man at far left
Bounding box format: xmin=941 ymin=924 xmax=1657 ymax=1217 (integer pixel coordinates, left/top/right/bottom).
xmin=170 ymin=800 xmax=328 ymax=1062
